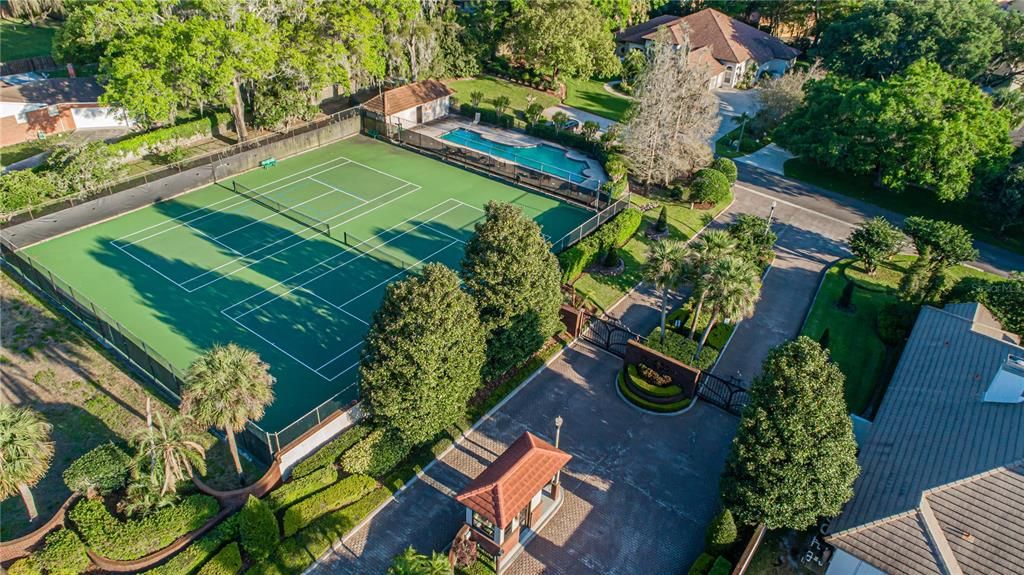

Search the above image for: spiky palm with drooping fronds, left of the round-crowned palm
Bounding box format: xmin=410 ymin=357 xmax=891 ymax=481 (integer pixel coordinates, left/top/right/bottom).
xmin=131 ymin=413 xmax=206 ymax=495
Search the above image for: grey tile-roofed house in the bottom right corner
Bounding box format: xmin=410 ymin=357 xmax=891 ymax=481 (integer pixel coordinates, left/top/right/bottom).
xmin=826 ymin=303 xmax=1024 ymax=575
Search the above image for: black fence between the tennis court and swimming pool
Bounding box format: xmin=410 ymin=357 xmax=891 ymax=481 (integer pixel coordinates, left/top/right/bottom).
xmin=362 ymin=114 xmax=613 ymax=212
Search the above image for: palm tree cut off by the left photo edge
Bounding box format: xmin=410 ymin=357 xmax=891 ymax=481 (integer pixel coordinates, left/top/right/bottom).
xmin=0 ymin=405 xmax=53 ymax=521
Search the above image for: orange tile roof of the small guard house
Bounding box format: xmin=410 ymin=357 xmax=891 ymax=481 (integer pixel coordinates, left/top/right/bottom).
xmin=456 ymin=432 xmax=572 ymax=529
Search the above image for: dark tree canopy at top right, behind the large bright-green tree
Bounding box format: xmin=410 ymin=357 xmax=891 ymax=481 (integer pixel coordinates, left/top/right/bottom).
xmin=818 ymin=0 xmax=1014 ymax=80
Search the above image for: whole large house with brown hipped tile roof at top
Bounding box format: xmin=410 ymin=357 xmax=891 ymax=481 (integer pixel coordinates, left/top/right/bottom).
xmin=615 ymin=8 xmax=800 ymax=88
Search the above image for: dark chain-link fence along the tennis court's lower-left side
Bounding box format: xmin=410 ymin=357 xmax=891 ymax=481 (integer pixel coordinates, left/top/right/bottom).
xmin=0 ymin=241 xmax=286 ymax=463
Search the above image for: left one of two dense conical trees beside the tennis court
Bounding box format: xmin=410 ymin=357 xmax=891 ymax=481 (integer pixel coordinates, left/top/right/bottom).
xmin=359 ymin=264 xmax=484 ymax=444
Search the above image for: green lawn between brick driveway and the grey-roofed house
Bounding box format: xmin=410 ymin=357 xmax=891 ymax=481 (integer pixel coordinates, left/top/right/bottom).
xmin=803 ymin=256 xmax=1000 ymax=414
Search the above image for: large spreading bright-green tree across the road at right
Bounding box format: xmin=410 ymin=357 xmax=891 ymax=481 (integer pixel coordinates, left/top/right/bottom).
xmin=775 ymin=61 xmax=1013 ymax=201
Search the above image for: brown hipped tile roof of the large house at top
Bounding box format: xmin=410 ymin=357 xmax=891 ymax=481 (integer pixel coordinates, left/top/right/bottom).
xmin=617 ymin=8 xmax=800 ymax=63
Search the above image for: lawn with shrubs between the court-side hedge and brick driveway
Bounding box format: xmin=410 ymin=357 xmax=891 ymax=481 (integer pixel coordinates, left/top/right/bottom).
xmin=573 ymin=191 xmax=732 ymax=311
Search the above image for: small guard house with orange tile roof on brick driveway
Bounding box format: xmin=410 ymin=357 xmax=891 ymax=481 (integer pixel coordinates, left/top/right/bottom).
xmin=456 ymin=432 xmax=572 ymax=575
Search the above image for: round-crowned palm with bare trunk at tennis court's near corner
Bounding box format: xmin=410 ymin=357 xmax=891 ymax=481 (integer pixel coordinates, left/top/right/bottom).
xmin=181 ymin=344 xmax=273 ymax=480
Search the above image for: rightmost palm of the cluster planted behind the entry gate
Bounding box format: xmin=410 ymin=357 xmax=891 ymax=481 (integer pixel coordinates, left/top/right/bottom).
xmin=693 ymin=256 xmax=761 ymax=361
